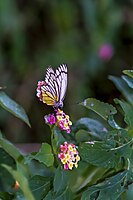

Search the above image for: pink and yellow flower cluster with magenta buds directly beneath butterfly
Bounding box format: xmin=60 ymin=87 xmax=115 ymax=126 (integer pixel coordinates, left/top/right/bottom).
xmin=45 ymin=109 xmax=72 ymax=133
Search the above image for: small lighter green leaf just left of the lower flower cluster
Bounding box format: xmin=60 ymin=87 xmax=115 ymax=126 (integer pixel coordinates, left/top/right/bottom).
xmin=34 ymin=143 xmax=54 ymax=167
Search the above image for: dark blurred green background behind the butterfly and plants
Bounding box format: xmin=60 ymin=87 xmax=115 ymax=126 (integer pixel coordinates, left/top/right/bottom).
xmin=0 ymin=0 xmax=133 ymax=143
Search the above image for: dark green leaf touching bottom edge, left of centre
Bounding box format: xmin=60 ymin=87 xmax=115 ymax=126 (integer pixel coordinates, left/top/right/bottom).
xmin=29 ymin=175 xmax=50 ymax=200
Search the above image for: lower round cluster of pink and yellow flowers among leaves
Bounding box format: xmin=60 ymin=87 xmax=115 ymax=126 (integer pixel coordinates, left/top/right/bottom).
xmin=58 ymin=142 xmax=80 ymax=170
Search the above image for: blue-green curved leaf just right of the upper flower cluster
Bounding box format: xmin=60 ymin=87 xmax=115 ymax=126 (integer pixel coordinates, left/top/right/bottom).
xmin=72 ymin=117 xmax=107 ymax=140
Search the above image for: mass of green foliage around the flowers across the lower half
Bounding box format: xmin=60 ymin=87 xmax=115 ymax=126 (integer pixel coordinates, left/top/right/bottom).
xmin=0 ymin=71 xmax=133 ymax=200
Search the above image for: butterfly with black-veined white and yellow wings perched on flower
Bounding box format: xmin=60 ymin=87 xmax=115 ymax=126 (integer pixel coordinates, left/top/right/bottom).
xmin=40 ymin=64 xmax=67 ymax=109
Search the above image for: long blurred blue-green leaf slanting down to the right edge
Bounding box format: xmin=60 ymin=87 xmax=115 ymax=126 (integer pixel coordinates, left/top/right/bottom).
xmin=109 ymin=76 xmax=133 ymax=104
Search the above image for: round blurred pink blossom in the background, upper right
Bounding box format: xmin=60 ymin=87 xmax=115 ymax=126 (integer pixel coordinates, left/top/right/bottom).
xmin=98 ymin=43 xmax=114 ymax=61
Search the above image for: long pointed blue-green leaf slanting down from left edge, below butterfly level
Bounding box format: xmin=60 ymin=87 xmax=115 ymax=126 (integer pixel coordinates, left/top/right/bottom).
xmin=0 ymin=91 xmax=31 ymax=127
